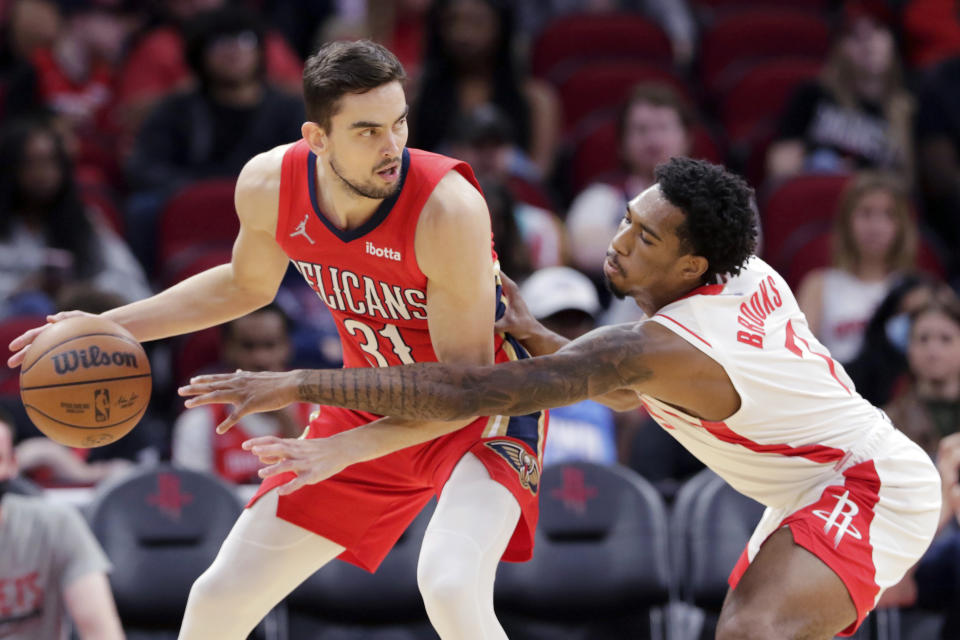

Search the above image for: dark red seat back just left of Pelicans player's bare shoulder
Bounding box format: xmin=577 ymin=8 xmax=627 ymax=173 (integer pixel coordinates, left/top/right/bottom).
xmin=157 ymin=180 xmax=240 ymax=273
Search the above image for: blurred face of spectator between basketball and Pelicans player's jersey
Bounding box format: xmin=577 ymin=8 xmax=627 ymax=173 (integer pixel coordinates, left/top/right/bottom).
xmin=223 ymin=311 xmax=290 ymax=371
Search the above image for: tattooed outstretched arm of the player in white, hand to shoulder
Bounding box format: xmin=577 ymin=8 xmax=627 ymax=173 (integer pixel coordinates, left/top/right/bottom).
xmin=180 ymin=324 xmax=670 ymax=420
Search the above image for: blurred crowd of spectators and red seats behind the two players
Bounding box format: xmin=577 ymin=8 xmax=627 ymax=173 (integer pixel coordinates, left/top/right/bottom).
xmin=0 ymin=0 xmax=960 ymax=637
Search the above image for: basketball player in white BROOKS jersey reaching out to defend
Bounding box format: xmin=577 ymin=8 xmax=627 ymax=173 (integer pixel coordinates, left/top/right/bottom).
xmin=181 ymin=159 xmax=940 ymax=640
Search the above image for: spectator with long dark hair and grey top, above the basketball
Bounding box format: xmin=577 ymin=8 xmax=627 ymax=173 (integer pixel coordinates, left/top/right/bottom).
xmin=0 ymin=119 xmax=150 ymax=315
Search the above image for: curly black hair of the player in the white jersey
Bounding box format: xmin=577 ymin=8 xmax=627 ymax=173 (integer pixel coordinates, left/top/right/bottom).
xmin=654 ymin=158 xmax=757 ymax=283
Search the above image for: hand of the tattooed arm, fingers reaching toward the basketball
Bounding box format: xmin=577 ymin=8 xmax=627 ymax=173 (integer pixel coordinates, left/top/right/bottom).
xmin=177 ymin=370 xmax=297 ymax=433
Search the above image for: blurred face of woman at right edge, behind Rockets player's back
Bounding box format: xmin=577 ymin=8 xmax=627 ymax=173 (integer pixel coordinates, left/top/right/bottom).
xmin=907 ymin=311 xmax=960 ymax=383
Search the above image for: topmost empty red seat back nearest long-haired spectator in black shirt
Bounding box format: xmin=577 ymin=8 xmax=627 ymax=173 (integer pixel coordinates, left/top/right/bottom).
xmin=700 ymin=8 xmax=830 ymax=96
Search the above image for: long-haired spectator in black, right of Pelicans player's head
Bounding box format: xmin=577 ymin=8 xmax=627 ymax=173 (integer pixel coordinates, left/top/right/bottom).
xmin=411 ymin=0 xmax=560 ymax=175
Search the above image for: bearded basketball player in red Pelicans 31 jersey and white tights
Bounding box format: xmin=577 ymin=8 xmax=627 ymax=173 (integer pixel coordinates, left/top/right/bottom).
xmin=10 ymin=41 xmax=568 ymax=640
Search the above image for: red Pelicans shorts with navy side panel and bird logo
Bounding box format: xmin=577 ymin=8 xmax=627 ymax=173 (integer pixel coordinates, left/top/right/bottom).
xmin=247 ymin=407 xmax=548 ymax=572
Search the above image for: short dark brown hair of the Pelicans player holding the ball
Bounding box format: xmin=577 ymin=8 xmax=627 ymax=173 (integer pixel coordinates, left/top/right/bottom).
xmin=303 ymin=40 xmax=407 ymax=131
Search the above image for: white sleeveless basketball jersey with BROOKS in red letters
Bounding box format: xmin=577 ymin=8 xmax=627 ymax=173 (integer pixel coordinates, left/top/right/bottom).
xmin=640 ymin=257 xmax=893 ymax=508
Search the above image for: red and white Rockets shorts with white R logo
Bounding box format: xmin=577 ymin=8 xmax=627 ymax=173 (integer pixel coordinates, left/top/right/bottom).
xmin=730 ymin=431 xmax=941 ymax=636
